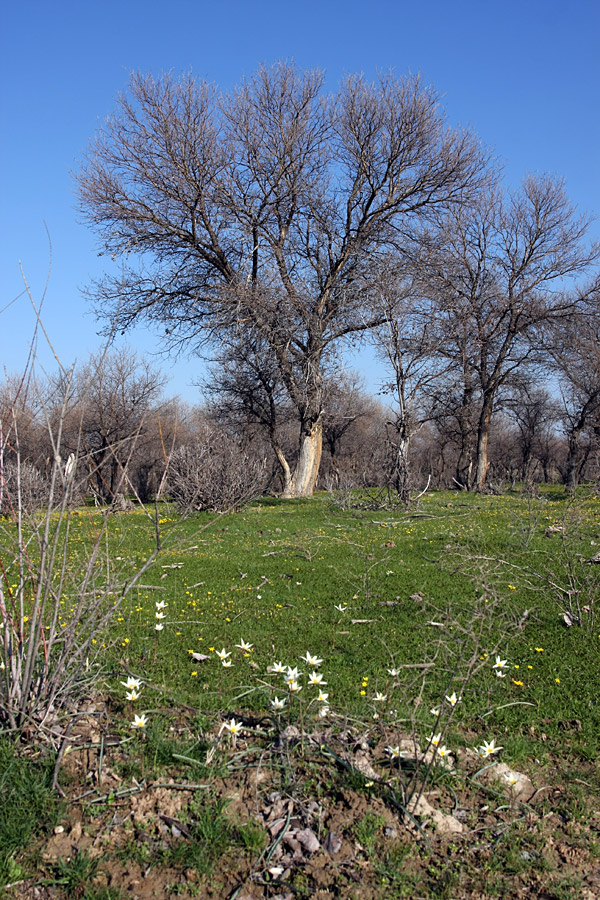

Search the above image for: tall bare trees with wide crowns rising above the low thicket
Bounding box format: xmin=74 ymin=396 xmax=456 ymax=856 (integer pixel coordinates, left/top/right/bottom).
xmin=77 ymin=62 xmax=600 ymax=496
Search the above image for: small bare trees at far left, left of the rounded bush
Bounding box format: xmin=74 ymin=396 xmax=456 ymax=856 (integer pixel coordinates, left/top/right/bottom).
xmin=0 ymin=350 xmax=173 ymax=506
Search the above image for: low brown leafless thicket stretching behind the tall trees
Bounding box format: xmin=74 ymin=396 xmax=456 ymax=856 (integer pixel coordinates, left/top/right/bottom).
xmin=0 ymin=338 xmax=600 ymax=513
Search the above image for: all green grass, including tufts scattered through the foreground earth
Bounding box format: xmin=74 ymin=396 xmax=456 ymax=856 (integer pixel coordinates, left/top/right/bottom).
xmin=0 ymin=488 xmax=600 ymax=896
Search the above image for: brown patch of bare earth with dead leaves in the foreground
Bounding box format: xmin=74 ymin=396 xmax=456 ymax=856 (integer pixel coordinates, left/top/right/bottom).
xmin=6 ymin=717 xmax=600 ymax=900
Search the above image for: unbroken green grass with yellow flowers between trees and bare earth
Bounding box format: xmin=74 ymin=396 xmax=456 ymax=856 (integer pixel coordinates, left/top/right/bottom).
xmin=71 ymin=491 xmax=600 ymax=759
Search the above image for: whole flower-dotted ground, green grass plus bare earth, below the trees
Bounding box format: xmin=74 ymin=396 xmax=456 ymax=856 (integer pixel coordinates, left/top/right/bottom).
xmin=0 ymin=487 xmax=600 ymax=900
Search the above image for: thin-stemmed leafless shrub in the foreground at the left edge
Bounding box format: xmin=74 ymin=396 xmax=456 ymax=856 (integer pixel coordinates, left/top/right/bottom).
xmin=0 ymin=362 xmax=164 ymax=744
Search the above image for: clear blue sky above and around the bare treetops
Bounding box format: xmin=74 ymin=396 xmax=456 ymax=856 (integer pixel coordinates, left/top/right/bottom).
xmin=0 ymin=0 xmax=600 ymax=402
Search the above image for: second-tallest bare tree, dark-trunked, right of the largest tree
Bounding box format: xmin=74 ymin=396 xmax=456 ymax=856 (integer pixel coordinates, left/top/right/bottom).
xmin=418 ymin=177 xmax=600 ymax=490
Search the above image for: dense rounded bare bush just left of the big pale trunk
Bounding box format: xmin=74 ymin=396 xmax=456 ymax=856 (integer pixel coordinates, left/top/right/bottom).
xmin=166 ymin=423 xmax=268 ymax=512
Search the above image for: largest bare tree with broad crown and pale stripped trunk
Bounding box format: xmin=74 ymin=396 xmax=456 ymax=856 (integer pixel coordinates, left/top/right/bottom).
xmin=78 ymin=63 xmax=485 ymax=496
